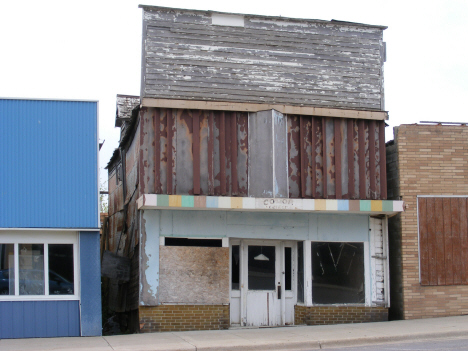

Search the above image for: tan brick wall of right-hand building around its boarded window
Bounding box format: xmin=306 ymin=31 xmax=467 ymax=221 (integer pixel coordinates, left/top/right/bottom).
xmin=387 ymin=125 xmax=468 ymax=319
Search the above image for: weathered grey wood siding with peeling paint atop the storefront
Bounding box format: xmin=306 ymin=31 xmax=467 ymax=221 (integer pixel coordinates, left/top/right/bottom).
xmin=141 ymin=6 xmax=385 ymax=110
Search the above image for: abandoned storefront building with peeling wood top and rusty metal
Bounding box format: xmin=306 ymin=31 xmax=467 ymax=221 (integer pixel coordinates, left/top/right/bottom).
xmin=105 ymin=6 xmax=403 ymax=332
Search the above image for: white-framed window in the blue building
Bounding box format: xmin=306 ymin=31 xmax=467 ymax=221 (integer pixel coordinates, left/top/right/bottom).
xmin=0 ymin=234 xmax=76 ymax=299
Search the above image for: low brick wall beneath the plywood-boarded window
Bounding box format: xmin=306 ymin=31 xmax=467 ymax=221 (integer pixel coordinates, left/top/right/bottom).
xmin=139 ymin=305 xmax=229 ymax=333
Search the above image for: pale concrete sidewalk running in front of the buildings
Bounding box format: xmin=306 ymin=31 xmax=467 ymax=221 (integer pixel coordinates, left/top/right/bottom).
xmin=0 ymin=316 xmax=468 ymax=351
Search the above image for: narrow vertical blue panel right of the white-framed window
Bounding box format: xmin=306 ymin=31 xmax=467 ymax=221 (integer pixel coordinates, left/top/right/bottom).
xmin=80 ymin=232 xmax=102 ymax=336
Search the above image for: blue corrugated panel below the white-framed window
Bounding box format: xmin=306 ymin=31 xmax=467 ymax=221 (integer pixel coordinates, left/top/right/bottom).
xmin=0 ymin=301 xmax=80 ymax=339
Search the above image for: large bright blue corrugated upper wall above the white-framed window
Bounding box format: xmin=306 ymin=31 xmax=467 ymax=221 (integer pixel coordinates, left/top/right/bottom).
xmin=0 ymin=99 xmax=99 ymax=228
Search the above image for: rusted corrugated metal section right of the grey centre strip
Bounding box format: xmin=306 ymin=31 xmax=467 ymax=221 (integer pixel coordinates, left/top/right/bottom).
xmin=287 ymin=116 xmax=386 ymax=199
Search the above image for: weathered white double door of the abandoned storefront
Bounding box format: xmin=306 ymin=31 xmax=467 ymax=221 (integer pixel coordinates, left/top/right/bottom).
xmin=231 ymin=240 xmax=296 ymax=326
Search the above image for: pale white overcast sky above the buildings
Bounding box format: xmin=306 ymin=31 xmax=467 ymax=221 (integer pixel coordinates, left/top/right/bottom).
xmin=0 ymin=0 xmax=468 ymax=187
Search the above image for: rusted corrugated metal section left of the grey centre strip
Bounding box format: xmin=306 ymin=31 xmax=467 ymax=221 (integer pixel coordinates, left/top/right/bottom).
xmin=148 ymin=108 xmax=248 ymax=196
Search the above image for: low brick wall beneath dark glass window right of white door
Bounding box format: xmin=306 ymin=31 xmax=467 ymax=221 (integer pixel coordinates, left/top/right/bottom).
xmin=294 ymin=305 xmax=388 ymax=325
